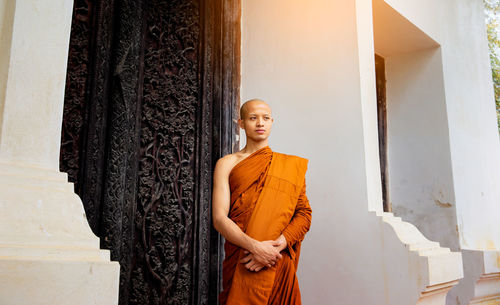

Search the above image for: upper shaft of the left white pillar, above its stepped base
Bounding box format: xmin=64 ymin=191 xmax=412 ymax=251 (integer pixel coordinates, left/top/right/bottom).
xmin=0 ymin=0 xmax=73 ymax=170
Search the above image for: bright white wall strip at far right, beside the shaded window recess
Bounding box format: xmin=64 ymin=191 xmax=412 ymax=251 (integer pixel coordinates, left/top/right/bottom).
xmin=386 ymin=0 xmax=500 ymax=249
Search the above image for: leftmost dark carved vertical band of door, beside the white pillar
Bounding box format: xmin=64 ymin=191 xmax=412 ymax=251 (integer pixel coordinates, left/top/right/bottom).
xmin=60 ymin=0 xmax=114 ymax=236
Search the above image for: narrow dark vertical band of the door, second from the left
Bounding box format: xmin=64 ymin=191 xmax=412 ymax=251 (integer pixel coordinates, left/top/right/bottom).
xmin=80 ymin=0 xmax=116 ymax=235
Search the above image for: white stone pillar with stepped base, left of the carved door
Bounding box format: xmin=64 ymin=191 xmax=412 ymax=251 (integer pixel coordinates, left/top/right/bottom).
xmin=0 ymin=0 xmax=119 ymax=305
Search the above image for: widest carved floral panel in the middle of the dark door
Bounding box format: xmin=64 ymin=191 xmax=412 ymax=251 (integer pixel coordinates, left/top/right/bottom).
xmin=131 ymin=0 xmax=200 ymax=304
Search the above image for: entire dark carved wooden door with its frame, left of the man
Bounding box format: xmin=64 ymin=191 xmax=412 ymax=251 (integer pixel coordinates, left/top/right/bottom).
xmin=61 ymin=0 xmax=240 ymax=305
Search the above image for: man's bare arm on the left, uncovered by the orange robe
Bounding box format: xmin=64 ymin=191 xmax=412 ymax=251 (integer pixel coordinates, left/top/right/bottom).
xmin=212 ymin=158 xmax=281 ymax=266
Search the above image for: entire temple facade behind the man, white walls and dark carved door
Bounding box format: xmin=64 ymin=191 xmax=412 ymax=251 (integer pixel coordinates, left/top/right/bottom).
xmin=0 ymin=0 xmax=500 ymax=305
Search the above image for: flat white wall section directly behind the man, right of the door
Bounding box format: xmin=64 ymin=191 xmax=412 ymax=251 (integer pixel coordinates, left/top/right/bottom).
xmin=241 ymin=0 xmax=384 ymax=304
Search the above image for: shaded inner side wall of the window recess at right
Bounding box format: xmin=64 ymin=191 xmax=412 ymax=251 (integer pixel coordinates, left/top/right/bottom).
xmin=386 ymin=48 xmax=460 ymax=251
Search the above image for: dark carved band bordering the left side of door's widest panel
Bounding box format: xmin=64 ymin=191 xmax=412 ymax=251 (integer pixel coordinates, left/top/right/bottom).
xmin=100 ymin=0 xmax=144 ymax=304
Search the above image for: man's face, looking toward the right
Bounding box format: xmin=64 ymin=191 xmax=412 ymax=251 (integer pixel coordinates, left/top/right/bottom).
xmin=239 ymin=101 xmax=274 ymax=142
